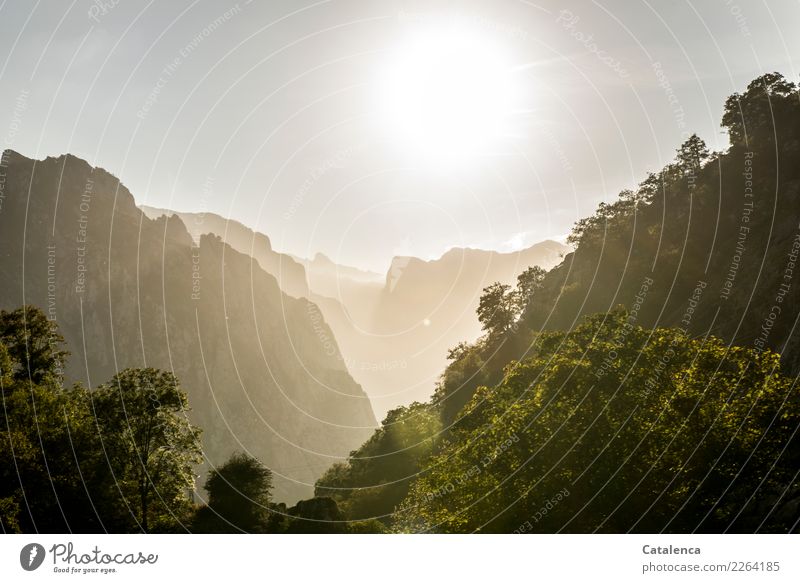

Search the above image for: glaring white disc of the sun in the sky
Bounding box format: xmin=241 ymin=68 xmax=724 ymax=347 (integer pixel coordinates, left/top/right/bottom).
xmin=378 ymin=28 xmax=518 ymax=162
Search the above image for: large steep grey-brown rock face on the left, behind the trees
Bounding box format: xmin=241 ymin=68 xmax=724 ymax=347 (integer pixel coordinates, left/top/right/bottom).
xmin=0 ymin=151 xmax=375 ymax=503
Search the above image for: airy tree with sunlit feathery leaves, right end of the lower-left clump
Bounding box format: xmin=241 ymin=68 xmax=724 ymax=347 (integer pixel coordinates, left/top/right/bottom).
xmin=93 ymin=368 xmax=202 ymax=532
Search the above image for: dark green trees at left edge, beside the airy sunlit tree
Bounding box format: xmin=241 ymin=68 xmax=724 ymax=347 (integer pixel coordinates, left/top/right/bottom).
xmin=0 ymin=306 xmax=104 ymax=532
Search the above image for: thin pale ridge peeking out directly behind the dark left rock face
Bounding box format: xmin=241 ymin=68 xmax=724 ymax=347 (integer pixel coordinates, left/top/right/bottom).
xmin=139 ymin=205 xmax=308 ymax=298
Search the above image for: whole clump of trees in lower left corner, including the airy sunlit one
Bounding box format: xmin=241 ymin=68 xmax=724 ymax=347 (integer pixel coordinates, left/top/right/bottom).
xmin=0 ymin=306 xmax=199 ymax=532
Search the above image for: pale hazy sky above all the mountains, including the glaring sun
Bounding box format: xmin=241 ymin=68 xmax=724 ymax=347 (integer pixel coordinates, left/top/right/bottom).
xmin=0 ymin=0 xmax=800 ymax=271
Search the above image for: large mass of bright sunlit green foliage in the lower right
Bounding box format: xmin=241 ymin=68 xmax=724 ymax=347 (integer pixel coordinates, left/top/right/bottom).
xmin=396 ymin=311 xmax=800 ymax=532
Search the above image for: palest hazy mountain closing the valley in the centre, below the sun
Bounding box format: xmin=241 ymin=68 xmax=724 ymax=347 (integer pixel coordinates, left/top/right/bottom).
xmin=312 ymin=241 xmax=568 ymax=418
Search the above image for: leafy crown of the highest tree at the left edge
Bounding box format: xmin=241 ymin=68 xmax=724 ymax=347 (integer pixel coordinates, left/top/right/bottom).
xmin=0 ymin=306 xmax=69 ymax=384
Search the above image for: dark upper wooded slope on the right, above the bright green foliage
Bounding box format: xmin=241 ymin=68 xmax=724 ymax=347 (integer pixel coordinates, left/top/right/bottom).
xmin=525 ymin=73 xmax=800 ymax=374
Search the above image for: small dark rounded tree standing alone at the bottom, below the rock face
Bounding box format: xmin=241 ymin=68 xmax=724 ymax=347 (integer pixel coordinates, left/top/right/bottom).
xmin=198 ymin=453 xmax=272 ymax=532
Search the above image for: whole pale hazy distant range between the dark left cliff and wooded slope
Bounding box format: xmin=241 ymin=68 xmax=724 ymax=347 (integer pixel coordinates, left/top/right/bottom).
xmin=140 ymin=207 xmax=569 ymax=417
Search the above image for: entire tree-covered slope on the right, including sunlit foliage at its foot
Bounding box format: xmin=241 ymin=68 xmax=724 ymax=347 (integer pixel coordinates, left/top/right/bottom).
xmin=316 ymin=73 xmax=800 ymax=533
